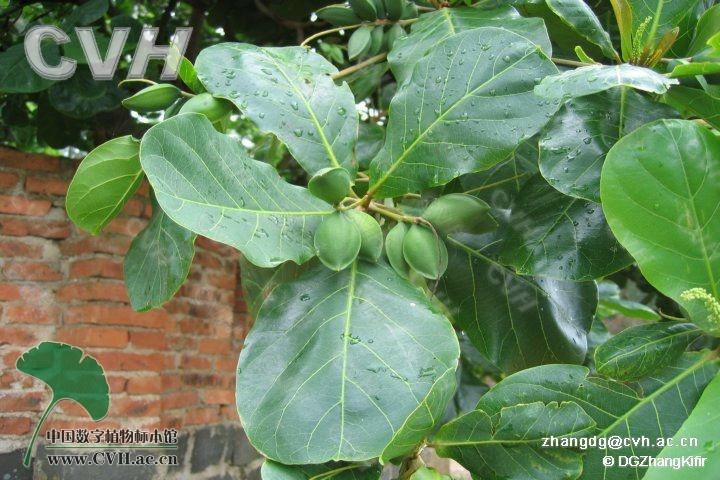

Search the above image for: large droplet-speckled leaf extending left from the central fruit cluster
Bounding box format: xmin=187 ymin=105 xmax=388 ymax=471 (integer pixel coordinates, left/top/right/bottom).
xmin=140 ymin=113 xmax=334 ymax=267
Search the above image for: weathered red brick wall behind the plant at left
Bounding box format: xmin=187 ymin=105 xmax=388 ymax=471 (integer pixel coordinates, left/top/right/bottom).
xmin=0 ymin=148 xmax=246 ymax=452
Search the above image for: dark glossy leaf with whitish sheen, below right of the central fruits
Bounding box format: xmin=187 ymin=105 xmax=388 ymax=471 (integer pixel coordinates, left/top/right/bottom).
xmin=442 ymin=238 xmax=597 ymax=372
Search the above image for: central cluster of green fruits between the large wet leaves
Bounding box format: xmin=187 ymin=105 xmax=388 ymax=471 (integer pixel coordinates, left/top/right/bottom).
xmin=308 ymin=168 xmax=496 ymax=280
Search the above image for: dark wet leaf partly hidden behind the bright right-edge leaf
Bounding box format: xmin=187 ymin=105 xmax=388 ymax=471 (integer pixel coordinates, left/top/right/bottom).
xmin=540 ymin=87 xmax=676 ymax=203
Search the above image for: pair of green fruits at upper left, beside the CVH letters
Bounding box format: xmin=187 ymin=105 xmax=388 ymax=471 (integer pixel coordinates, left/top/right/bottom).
xmin=122 ymin=83 xmax=233 ymax=129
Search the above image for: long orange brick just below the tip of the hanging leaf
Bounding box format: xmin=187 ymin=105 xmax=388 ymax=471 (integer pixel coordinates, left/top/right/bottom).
xmin=65 ymin=305 xmax=171 ymax=328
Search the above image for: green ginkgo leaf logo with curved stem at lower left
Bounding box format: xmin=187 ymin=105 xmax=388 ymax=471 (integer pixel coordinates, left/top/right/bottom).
xmin=15 ymin=342 xmax=110 ymax=467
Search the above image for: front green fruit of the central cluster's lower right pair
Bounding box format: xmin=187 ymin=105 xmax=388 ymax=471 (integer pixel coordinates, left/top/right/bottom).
xmin=403 ymin=225 xmax=448 ymax=280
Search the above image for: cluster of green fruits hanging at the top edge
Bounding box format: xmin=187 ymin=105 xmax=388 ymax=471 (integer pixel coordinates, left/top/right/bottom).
xmin=317 ymin=0 xmax=418 ymax=60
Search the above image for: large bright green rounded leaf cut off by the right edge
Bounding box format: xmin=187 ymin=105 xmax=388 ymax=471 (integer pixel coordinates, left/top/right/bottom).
xmin=600 ymin=120 xmax=720 ymax=333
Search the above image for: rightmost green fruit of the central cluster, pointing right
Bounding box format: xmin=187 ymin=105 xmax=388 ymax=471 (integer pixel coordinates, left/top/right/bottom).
xmin=422 ymin=193 xmax=497 ymax=235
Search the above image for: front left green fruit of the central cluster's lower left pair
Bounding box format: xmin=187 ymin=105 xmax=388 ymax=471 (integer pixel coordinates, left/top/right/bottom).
xmin=315 ymin=212 xmax=362 ymax=271
